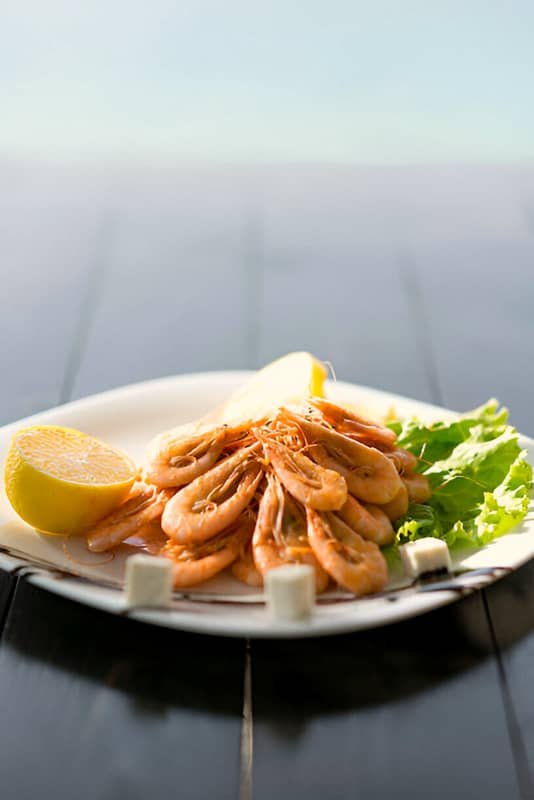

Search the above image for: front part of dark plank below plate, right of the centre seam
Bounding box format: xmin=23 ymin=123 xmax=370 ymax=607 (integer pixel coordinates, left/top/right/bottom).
xmin=252 ymin=595 xmax=520 ymax=800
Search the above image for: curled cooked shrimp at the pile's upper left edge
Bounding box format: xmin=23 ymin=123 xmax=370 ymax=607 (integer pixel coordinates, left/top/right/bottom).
xmin=143 ymin=425 xmax=227 ymax=487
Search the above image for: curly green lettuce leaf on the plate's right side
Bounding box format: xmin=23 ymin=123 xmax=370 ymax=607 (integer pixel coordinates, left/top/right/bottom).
xmin=390 ymin=400 xmax=532 ymax=546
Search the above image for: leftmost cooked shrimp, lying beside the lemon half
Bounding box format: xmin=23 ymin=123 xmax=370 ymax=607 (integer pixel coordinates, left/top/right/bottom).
xmin=87 ymin=481 xmax=173 ymax=553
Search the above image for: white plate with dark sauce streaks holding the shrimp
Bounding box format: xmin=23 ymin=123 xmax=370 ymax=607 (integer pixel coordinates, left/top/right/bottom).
xmin=0 ymin=372 xmax=534 ymax=637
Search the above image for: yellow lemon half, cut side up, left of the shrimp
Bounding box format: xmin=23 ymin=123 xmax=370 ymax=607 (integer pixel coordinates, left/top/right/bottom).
xmin=4 ymin=425 xmax=136 ymax=534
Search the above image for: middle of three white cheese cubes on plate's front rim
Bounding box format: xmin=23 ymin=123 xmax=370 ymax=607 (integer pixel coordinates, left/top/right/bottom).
xmin=265 ymin=564 xmax=315 ymax=620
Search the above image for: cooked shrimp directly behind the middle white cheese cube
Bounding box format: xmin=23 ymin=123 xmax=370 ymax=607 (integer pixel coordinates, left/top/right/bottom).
xmin=252 ymin=475 xmax=328 ymax=592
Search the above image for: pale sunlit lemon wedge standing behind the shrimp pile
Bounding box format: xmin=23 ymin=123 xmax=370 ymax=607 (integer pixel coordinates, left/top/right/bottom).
xmin=217 ymin=352 xmax=327 ymax=423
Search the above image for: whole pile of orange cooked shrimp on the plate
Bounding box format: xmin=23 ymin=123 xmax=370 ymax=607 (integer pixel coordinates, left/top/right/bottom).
xmin=87 ymin=398 xmax=430 ymax=595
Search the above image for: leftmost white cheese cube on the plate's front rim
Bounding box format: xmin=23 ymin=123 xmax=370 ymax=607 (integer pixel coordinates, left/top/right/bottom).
xmin=125 ymin=553 xmax=173 ymax=608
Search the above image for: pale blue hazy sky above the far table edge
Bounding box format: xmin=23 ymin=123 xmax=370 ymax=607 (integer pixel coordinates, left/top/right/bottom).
xmin=0 ymin=0 xmax=534 ymax=163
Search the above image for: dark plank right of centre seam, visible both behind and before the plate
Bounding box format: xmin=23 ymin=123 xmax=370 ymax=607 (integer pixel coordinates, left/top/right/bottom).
xmin=252 ymin=175 xmax=519 ymax=800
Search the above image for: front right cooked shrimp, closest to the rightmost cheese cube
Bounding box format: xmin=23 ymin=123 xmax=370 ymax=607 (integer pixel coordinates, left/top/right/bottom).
xmin=307 ymin=508 xmax=388 ymax=595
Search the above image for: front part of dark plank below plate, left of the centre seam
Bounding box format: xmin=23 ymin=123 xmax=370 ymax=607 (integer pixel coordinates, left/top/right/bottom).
xmin=0 ymin=580 xmax=244 ymax=800
